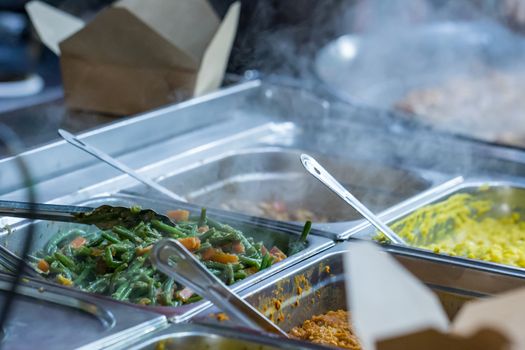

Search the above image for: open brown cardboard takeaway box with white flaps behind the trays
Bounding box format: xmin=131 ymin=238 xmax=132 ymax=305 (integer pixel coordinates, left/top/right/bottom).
xmin=26 ymin=0 xmax=240 ymax=115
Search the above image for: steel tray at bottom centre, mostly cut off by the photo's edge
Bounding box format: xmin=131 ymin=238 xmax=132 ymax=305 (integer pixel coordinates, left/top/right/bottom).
xmin=119 ymin=324 xmax=325 ymax=350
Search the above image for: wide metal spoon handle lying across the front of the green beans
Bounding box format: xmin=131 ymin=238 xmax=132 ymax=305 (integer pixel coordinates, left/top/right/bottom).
xmin=151 ymin=238 xmax=288 ymax=337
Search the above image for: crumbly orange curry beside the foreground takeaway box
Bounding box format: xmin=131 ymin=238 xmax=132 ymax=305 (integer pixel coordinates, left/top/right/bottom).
xmin=289 ymin=310 xmax=361 ymax=350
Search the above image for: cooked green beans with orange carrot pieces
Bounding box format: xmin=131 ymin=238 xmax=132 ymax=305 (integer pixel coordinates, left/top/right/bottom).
xmin=35 ymin=208 xmax=310 ymax=306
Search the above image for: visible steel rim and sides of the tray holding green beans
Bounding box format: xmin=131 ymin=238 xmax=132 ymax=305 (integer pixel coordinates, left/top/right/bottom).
xmin=0 ymin=195 xmax=334 ymax=322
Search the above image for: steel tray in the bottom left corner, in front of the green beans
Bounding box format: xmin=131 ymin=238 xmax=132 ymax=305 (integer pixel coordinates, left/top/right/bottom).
xmin=0 ymin=274 xmax=167 ymax=350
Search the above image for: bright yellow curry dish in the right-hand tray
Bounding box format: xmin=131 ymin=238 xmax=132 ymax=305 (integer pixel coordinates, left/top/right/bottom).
xmin=384 ymin=193 xmax=525 ymax=268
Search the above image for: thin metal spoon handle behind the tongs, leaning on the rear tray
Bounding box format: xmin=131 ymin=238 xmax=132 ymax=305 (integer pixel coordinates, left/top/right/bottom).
xmin=58 ymin=129 xmax=187 ymax=202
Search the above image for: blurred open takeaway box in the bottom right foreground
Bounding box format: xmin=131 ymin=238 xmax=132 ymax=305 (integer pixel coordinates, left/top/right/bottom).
xmin=345 ymin=242 xmax=525 ymax=350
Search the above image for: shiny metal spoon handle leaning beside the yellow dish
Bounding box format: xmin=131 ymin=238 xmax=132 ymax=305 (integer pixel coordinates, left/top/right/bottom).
xmin=301 ymin=153 xmax=407 ymax=245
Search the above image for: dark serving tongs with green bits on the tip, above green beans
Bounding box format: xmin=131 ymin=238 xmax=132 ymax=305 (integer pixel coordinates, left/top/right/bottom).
xmin=0 ymin=201 xmax=172 ymax=230
